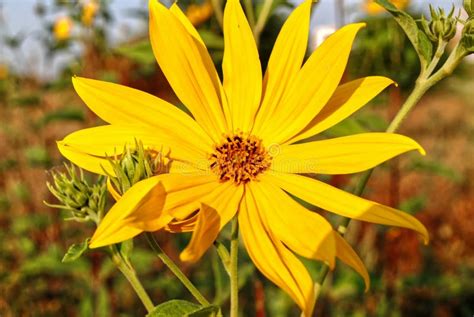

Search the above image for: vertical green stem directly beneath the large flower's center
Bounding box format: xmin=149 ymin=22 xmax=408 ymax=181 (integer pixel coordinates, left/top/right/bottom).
xmin=229 ymin=216 xmax=239 ymax=317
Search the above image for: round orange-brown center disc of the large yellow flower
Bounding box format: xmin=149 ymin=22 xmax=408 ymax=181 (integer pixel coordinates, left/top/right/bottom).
xmin=210 ymin=135 xmax=271 ymax=185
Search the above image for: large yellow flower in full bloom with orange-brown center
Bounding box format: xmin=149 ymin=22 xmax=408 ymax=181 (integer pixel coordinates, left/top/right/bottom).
xmin=58 ymin=0 xmax=428 ymax=316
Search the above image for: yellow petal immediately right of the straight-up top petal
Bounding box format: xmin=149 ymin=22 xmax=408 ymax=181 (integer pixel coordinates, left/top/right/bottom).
xmin=253 ymin=0 xmax=312 ymax=135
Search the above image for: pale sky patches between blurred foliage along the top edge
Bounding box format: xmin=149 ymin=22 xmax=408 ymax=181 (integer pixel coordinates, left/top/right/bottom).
xmin=0 ymin=0 xmax=462 ymax=78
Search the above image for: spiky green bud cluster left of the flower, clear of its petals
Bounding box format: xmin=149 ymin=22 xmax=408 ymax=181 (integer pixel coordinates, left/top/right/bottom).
xmin=45 ymin=165 xmax=107 ymax=222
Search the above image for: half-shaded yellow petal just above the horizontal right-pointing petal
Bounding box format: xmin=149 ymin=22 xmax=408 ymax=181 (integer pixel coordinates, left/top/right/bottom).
xmin=288 ymin=76 xmax=394 ymax=143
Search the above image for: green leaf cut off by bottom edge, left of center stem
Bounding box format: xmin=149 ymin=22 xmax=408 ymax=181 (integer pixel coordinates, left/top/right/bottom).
xmin=147 ymin=299 xmax=219 ymax=317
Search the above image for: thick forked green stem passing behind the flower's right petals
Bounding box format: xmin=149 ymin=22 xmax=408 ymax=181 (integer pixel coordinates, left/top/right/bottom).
xmin=316 ymin=37 xmax=467 ymax=299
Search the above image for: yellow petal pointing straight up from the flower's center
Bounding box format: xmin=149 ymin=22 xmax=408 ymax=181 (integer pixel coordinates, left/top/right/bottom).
xmin=222 ymin=0 xmax=262 ymax=132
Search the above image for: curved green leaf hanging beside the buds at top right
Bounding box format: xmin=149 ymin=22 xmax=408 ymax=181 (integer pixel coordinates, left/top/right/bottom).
xmin=375 ymin=0 xmax=433 ymax=69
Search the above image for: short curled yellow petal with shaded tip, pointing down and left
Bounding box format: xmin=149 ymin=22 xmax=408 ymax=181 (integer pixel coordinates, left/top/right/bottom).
xmin=180 ymin=182 xmax=243 ymax=262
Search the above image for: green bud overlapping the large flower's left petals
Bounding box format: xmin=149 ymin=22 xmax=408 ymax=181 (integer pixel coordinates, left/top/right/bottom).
xmin=108 ymin=141 xmax=162 ymax=194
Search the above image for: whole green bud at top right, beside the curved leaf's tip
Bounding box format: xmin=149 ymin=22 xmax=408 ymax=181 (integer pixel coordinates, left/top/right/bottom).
xmin=421 ymin=5 xmax=457 ymax=43
